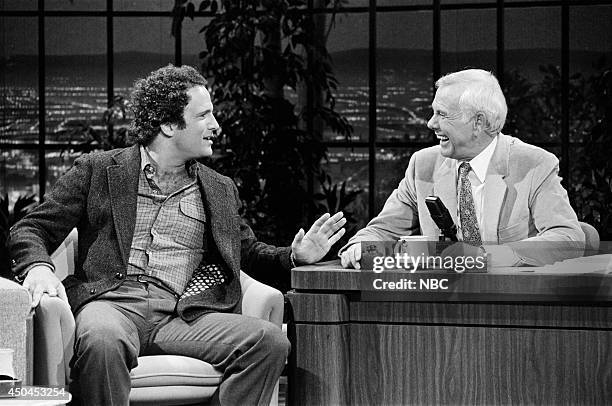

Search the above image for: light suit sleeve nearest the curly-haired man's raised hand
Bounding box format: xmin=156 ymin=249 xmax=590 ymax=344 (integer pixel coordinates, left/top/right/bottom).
xmin=339 ymin=153 xmax=419 ymax=254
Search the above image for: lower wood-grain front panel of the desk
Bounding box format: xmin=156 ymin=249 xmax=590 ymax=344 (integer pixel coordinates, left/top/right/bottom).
xmin=350 ymin=323 xmax=612 ymax=405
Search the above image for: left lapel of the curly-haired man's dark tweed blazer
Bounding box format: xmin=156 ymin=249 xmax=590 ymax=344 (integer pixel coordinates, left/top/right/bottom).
xmin=106 ymin=144 xmax=140 ymax=264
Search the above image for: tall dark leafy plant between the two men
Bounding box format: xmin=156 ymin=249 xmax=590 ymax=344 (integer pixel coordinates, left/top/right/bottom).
xmin=174 ymin=0 xmax=352 ymax=244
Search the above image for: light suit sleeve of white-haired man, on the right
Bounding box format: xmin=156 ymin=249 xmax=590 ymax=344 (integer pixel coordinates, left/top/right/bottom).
xmin=506 ymin=154 xmax=585 ymax=266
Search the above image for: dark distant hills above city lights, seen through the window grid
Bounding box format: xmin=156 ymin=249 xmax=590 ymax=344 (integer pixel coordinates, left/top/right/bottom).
xmin=0 ymin=48 xmax=612 ymax=87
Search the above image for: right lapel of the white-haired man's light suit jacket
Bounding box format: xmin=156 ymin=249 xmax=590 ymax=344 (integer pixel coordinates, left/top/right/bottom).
xmin=483 ymin=134 xmax=510 ymax=244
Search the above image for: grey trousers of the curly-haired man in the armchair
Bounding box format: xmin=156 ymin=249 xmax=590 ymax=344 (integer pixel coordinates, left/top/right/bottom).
xmin=71 ymin=280 xmax=290 ymax=405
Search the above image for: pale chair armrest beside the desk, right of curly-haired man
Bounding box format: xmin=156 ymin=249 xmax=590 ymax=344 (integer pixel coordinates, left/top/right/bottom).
xmin=240 ymin=271 xmax=285 ymax=328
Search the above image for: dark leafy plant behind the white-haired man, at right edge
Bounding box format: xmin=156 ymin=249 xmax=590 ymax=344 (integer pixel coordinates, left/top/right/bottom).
xmin=504 ymin=59 xmax=612 ymax=240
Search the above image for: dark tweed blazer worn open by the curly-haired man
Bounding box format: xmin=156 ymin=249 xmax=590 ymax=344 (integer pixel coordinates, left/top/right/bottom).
xmin=9 ymin=145 xmax=291 ymax=320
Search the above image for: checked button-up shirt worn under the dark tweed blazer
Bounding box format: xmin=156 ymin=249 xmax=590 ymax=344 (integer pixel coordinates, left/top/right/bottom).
xmin=128 ymin=147 xmax=206 ymax=295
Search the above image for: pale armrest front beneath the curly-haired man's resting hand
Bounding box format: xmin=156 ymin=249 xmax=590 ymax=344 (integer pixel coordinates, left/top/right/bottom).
xmin=34 ymin=294 xmax=75 ymax=385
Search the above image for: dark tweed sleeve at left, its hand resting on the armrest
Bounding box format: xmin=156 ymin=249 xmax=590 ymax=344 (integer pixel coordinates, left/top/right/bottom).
xmin=8 ymin=155 xmax=92 ymax=276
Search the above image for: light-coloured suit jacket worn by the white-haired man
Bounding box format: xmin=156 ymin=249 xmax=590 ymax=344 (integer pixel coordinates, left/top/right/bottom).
xmin=340 ymin=134 xmax=585 ymax=265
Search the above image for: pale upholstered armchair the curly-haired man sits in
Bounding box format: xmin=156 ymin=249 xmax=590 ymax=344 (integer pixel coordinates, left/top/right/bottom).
xmin=34 ymin=230 xmax=284 ymax=405
